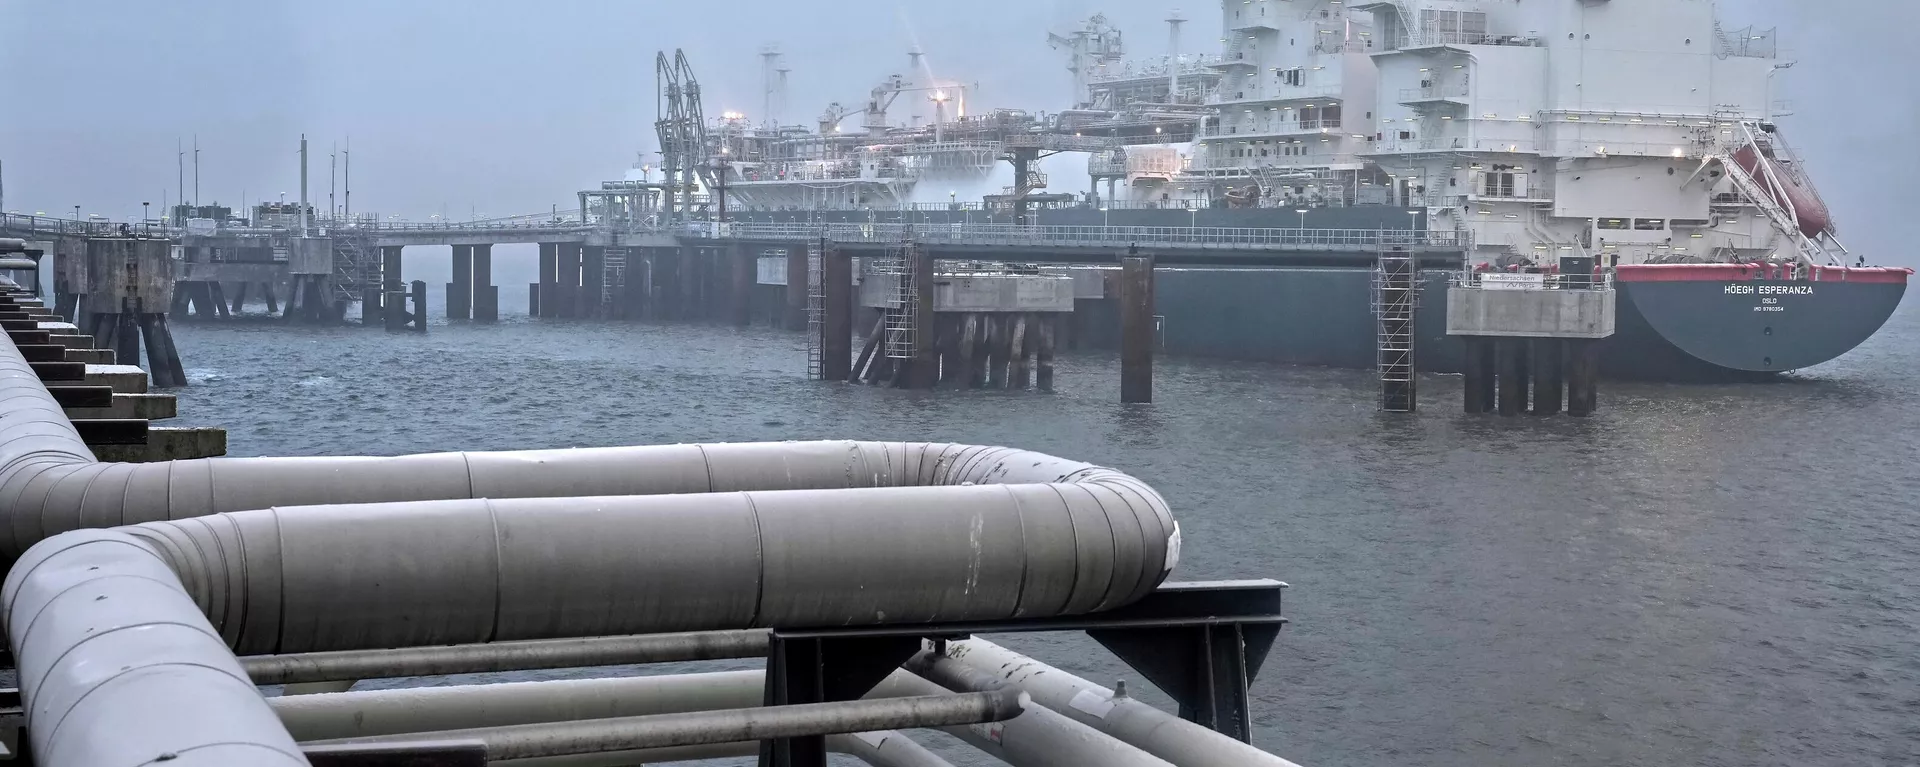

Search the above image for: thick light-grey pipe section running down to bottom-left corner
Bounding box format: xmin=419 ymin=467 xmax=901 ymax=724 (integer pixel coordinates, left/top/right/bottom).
xmin=0 ymin=530 xmax=307 ymax=767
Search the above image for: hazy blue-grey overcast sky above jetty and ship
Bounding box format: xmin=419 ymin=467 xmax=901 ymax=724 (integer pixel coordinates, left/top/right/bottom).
xmin=0 ymin=0 xmax=1920 ymax=263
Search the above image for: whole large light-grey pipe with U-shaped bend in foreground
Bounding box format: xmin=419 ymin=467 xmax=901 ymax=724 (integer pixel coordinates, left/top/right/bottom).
xmin=0 ymin=334 xmax=1179 ymax=767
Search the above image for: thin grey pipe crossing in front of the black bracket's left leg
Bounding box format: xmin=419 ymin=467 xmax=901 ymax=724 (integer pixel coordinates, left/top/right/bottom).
xmin=299 ymin=690 xmax=1027 ymax=761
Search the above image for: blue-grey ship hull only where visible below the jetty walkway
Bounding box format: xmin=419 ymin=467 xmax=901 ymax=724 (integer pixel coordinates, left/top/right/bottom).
xmin=1075 ymin=267 xmax=1907 ymax=383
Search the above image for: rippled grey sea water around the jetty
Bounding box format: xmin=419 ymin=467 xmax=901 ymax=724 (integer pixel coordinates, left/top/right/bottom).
xmin=177 ymin=302 xmax=1920 ymax=767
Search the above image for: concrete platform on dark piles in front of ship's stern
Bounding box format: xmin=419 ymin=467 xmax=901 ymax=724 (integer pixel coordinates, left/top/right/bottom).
xmin=1446 ymin=265 xmax=1617 ymax=417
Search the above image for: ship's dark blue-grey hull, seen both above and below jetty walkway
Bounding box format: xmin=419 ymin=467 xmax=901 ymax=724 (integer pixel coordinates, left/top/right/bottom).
xmin=725 ymin=206 xmax=1908 ymax=381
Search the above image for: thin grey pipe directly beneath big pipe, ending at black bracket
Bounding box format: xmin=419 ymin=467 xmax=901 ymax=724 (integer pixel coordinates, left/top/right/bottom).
xmin=240 ymin=631 xmax=768 ymax=684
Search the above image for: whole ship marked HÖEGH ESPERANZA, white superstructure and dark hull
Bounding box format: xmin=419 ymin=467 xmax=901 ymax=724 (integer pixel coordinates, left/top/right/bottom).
xmin=679 ymin=0 xmax=1910 ymax=379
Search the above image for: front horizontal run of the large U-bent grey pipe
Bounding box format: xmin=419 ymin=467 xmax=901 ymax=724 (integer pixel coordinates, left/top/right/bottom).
xmin=127 ymin=484 xmax=1165 ymax=654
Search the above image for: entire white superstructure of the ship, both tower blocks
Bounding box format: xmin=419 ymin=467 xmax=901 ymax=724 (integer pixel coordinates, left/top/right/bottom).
xmin=1113 ymin=0 xmax=1847 ymax=271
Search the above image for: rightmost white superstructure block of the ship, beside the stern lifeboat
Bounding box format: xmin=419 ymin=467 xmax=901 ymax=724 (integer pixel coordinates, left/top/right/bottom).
xmin=1359 ymin=0 xmax=1830 ymax=263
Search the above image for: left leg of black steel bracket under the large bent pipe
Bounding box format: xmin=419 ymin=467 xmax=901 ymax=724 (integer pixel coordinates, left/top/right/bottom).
xmin=760 ymin=631 xmax=922 ymax=767
